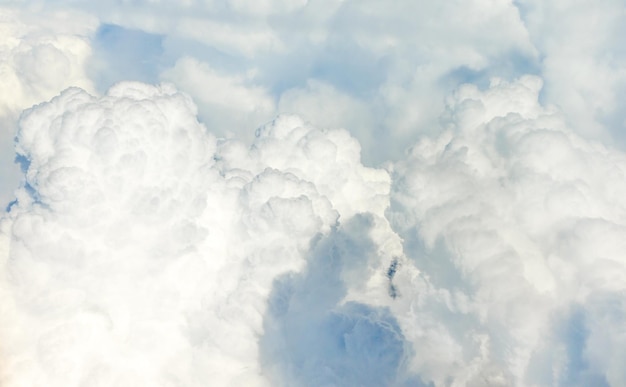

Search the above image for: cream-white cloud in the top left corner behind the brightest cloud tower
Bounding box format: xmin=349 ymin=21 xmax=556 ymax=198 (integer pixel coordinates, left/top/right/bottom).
xmin=0 ymin=7 xmax=97 ymax=208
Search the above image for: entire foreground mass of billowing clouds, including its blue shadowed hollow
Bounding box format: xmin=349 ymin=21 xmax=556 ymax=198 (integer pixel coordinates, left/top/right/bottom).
xmin=0 ymin=76 xmax=626 ymax=386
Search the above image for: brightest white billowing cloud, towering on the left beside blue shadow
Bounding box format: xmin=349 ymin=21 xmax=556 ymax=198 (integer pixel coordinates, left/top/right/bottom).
xmin=1 ymin=83 xmax=390 ymax=386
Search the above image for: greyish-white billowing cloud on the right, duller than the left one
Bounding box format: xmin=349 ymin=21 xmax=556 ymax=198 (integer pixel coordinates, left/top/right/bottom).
xmin=388 ymin=77 xmax=626 ymax=385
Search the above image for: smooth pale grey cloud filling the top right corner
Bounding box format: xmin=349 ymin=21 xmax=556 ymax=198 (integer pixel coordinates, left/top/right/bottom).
xmin=520 ymin=1 xmax=626 ymax=144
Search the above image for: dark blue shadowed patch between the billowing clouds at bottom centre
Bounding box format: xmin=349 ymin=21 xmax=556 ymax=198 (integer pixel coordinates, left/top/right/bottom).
xmin=261 ymin=216 xmax=420 ymax=386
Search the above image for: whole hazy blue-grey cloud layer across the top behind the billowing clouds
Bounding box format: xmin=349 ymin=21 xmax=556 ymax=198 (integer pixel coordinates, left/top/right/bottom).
xmin=3 ymin=0 xmax=626 ymax=205
